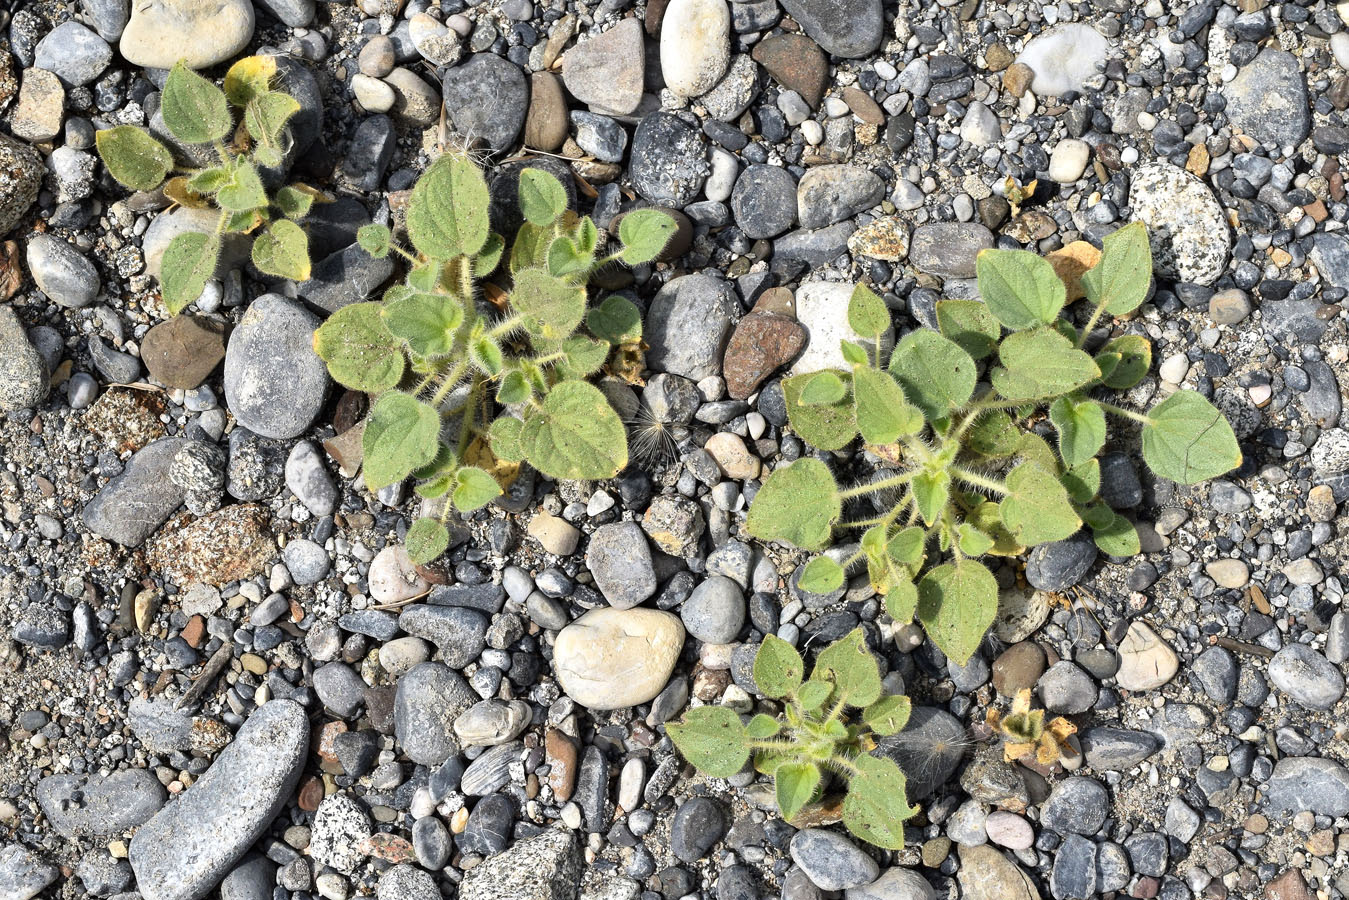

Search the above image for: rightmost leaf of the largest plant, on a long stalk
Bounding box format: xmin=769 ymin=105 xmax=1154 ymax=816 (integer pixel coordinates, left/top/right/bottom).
xmin=1143 ymin=390 xmax=1241 ymax=484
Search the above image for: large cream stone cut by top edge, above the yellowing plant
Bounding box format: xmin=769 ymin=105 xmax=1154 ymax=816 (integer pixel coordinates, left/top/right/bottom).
xmin=117 ymin=0 xmax=254 ymax=69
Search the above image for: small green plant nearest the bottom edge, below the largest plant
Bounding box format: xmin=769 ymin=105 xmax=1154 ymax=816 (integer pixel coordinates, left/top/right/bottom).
xmin=666 ymin=629 xmax=917 ymax=850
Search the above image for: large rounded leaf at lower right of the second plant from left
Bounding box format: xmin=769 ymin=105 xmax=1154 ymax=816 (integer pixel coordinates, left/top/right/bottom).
xmin=521 ymin=382 xmax=627 ymax=480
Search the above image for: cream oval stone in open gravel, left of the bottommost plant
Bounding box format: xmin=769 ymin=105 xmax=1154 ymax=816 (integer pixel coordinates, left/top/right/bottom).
xmin=553 ymin=607 xmax=684 ymax=710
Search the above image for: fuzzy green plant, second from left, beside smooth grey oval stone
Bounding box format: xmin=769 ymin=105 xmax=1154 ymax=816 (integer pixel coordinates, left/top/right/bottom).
xmin=314 ymin=154 xmax=675 ymax=563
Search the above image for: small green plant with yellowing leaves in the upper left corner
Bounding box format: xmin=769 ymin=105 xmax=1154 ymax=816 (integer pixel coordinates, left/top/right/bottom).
xmin=94 ymin=57 xmax=322 ymax=314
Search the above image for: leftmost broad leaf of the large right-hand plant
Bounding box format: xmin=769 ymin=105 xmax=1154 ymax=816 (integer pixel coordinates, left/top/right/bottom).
xmin=746 ymin=457 xmax=843 ymax=551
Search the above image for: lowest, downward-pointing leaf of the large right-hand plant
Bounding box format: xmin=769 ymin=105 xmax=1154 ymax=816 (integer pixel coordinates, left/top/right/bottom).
xmin=917 ymin=559 xmax=998 ymax=665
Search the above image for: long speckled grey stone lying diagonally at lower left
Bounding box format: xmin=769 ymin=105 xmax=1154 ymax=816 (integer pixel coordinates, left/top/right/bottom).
xmin=131 ymin=700 xmax=309 ymax=900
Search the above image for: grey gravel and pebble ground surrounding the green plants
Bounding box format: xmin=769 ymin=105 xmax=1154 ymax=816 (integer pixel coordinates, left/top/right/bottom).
xmin=0 ymin=0 xmax=1349 ymax=900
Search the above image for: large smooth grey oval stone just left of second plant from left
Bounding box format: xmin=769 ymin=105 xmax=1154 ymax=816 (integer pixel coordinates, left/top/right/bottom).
xmin=225 ymin=294 xmax=328 ymax=439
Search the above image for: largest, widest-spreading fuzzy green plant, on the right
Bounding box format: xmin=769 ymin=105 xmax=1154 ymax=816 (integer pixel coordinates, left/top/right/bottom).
xmin=747 ymin=224 xmax=1241 ymax=664
